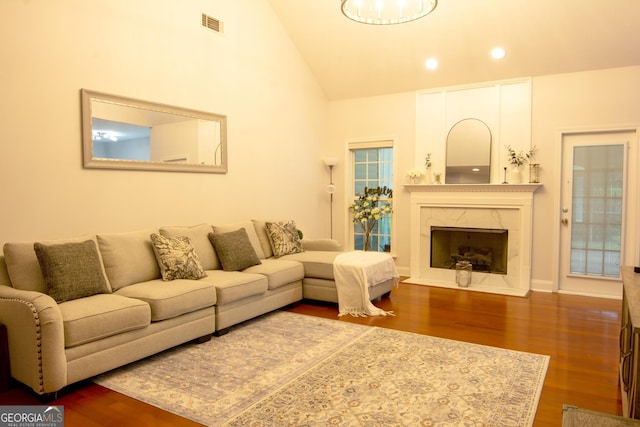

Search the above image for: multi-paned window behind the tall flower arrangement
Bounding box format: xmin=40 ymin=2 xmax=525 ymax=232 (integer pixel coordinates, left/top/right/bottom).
xmin=349 ymin=141 xmax=393 ymax=252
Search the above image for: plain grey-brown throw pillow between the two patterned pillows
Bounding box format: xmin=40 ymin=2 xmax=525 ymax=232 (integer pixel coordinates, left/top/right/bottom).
xmin=209 ymin=228 xmax=262 ymax=271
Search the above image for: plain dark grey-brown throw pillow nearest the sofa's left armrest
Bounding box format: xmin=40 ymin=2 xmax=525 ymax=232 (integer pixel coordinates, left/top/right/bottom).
xmin=33 ymin=240 xmax=111 ymax=303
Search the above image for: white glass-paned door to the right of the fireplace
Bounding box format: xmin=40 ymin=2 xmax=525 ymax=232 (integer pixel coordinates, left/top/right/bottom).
xmin=558 ymin=131 xmax=636 ymax=298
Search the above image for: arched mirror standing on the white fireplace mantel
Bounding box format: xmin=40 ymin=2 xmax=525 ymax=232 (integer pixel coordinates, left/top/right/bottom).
xmin=445 ymin=119 xmax=491 ymax=184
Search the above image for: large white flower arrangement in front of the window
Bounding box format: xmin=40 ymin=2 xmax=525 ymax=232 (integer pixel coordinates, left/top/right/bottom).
xmin=349 ymin=187 xmax=393 ymax=251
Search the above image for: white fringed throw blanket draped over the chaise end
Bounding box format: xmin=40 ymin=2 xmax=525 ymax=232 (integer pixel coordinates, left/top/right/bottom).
xmin=333 ymin=251 xmax=400 ymax=317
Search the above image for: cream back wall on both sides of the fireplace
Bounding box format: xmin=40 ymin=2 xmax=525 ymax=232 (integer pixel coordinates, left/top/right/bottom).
xmin=328 ymin=67 xmax=640 ymax=290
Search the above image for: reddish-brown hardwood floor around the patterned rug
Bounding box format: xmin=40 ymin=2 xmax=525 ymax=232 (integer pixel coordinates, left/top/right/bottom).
xmin=0 ymin=284 xmax=622 ymax=427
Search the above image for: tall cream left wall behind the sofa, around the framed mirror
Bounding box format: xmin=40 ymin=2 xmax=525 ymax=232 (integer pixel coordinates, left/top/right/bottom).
xmin=0 ymin=0 xmax=328 ymax=245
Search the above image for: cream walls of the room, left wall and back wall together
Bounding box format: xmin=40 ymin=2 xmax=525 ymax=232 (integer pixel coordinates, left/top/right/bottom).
xmin=0 ymin=0 xmax=640 ymax=288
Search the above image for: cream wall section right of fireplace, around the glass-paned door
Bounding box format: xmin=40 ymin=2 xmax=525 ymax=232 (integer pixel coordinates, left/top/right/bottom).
xmin=532 ymin=67 xmax=640 ymax=290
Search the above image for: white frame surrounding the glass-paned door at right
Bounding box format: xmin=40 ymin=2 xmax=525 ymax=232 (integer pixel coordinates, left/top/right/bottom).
xmin=552 ymin=124 xmax=640 ymax=297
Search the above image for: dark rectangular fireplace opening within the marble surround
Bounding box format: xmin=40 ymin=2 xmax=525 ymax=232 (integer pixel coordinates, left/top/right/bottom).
xmin=430 ymin=226 xmax=509 ymax=274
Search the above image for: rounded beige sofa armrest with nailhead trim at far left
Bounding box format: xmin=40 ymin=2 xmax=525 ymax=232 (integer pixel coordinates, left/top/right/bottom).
xmin=0 ymin=286 xmax=67 ymax=395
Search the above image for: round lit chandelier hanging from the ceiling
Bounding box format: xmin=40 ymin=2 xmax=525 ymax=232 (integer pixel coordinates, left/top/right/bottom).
xmin=342 ymin=0 xmax=438 ymax=25
